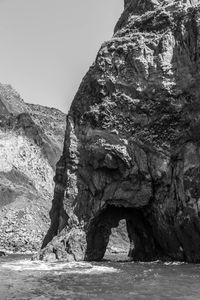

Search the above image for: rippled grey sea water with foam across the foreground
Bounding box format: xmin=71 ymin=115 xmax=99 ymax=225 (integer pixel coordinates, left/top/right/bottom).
xmin=0 ymin=256 xmax=200 ymax=300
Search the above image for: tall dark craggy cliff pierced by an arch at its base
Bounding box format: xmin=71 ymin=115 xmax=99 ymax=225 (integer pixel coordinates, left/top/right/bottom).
xmin=40 ymin=0 xmax=200 ymax=262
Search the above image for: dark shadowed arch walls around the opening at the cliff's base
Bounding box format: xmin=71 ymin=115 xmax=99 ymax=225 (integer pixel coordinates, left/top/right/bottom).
xmin=85 ymin=205 xmax=158 ymax=261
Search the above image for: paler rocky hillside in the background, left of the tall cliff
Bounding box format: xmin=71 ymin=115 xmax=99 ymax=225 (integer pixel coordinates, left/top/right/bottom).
xmin=0 ymin=84 xmax=66 ymax=252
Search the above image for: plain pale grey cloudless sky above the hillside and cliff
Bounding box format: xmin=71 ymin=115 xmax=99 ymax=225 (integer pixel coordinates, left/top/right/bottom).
xmin=0 ymin=0 xmax=124 ymax=112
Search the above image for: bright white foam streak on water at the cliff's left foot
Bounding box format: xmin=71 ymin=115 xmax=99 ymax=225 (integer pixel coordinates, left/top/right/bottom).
xmin=1 ymin=260 xmax=118 ymax=274
